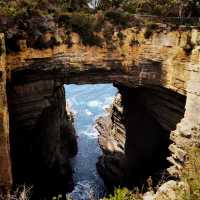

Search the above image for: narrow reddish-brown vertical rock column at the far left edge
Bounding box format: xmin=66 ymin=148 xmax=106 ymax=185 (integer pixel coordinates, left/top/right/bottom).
xmin=0 ymin=34 xmax=12 ymax=193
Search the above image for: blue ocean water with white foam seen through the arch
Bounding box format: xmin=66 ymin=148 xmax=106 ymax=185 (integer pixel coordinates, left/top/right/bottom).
xmin=65 ymin=84 xmax=117 ymax=200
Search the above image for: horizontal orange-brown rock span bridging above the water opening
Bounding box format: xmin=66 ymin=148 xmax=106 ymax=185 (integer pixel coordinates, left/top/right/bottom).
xmin=7 ymin=27 xmax=199 ymax=95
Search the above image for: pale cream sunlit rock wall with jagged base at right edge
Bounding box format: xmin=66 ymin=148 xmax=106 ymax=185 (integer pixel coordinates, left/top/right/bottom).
xmin=169 ymin=47 xmax=200 ymax=176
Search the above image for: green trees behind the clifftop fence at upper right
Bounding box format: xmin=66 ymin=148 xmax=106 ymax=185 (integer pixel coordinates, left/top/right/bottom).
xmin=98 ymin=0 xmax=200 ymax=17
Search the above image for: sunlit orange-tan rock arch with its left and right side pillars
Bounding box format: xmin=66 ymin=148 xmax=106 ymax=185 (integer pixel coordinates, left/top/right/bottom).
xmin=0 ymin=28 xmax=200 ymax=195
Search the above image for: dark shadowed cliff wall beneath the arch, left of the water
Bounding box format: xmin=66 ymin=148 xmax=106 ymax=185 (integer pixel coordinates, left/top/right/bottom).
xmin=8 ymin=81 xmax=77 ymax=193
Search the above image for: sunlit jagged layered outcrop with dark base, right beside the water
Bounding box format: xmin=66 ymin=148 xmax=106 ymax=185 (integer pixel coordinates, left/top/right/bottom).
xmin=96 ymin=93 xmax=126 ymax=186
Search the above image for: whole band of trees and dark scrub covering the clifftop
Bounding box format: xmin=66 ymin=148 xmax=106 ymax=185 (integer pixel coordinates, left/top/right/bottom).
xmin=0 ymin=0 xmax=200 ymax=48
